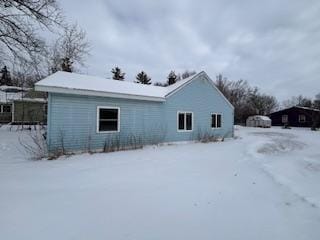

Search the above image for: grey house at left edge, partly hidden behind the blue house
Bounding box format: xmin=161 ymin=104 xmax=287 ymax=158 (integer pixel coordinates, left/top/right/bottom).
xmin=0 ymin=85 xmax=47 ymax=124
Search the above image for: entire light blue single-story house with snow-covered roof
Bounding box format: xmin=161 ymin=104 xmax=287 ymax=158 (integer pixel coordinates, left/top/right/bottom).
xmin=35 ymin=72 xmax=234 ymax=151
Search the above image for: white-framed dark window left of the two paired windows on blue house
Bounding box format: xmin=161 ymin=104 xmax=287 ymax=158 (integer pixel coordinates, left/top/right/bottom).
xmin=97 ymin=107 xmax=120 ymax=132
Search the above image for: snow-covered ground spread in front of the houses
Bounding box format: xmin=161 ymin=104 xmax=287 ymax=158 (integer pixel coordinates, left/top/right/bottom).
xmin=0 ymin=127 xmax=320 ymax=240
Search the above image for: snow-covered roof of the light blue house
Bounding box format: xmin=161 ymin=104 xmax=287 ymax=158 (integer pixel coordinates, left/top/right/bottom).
xmin=35 ymin=71 xmax=232 ymax=106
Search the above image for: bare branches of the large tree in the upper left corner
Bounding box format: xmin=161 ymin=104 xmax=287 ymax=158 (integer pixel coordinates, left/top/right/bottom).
xmin=0 ymin=0 xmax=63 ymax=61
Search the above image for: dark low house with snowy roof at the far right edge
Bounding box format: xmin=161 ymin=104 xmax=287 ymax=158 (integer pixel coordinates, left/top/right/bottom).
xmin=269 ymin=106 xmax=320 ymax=127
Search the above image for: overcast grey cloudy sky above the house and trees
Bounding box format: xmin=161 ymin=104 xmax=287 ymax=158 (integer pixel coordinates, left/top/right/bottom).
xmin=60 ymin=0 xmax=320 ymax=100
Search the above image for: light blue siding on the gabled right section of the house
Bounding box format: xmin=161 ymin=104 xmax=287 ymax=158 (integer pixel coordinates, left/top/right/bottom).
xmin=165 ymin=74 xmax=233 ymax=142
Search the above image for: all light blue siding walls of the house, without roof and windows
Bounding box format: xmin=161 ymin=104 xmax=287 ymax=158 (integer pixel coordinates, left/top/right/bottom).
xmin=47 ymin=77 xmax=233 ymax=151
